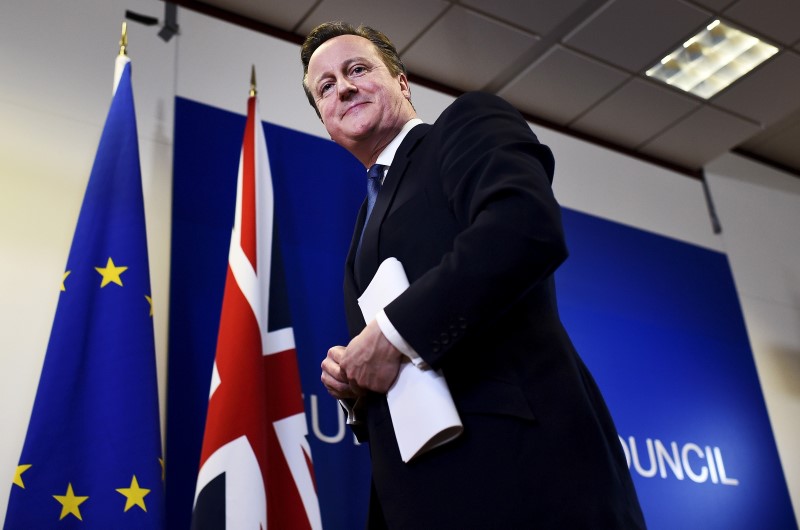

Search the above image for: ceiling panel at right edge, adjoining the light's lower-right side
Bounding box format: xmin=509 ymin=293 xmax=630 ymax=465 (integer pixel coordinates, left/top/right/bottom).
xmin=712 ymin=52 xmax=800 ymax=126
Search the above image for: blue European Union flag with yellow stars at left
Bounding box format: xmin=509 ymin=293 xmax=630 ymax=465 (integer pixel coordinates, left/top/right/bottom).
xmin=5 ymin=57 xmax=164 ymax=530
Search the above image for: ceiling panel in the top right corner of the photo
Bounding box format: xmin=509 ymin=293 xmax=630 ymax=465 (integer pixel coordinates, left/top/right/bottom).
xmin=724 ymin=0 xmax=800 ymax=46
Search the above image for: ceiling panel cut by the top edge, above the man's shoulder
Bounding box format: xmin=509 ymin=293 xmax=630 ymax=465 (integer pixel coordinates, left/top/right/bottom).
xmin=461 ymin=0 xmax=586 ymax=35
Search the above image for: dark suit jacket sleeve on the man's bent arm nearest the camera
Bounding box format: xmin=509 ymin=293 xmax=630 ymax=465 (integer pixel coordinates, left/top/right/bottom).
xmin=385 ymin=93 xmax=567 ymax=368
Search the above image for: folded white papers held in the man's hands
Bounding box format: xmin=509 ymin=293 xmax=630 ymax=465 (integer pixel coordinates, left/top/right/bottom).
xmin=358 ymin=258 xmax=464 ymax=463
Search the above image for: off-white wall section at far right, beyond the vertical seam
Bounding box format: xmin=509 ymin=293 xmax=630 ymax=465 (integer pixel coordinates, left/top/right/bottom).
xmin=706 ymin=154 xmax=800 ymax=521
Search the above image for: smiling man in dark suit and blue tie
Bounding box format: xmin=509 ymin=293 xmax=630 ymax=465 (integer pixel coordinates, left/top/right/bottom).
xmin=301 ymin=23 xmax=644 ymax=529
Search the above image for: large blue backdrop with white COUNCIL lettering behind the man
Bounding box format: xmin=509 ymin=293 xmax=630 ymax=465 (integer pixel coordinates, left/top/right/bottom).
xmin=166 ymin=98 xmax=797 ymax=529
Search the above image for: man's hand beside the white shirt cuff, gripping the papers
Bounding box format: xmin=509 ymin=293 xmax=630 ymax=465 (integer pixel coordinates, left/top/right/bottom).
xmin=340 ymin=320 xmax=404 ymax=394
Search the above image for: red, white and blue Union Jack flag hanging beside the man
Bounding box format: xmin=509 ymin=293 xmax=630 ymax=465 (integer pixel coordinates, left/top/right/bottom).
xmin=192 ymin=96 xmax=322 ymax=530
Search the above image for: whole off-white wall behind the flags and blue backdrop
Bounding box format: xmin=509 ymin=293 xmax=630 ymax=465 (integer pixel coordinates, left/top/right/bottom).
xmin=0 ymin=0 xmax=800 ymax=516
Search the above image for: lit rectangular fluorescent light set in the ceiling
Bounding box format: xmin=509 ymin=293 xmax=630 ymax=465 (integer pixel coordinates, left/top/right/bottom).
xmin=647 ymin=20 xmax=778 ymax=99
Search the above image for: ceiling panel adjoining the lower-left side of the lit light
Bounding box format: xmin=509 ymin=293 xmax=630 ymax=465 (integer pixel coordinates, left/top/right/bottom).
xmin=571 ymin=79 xmax=700 ymax=148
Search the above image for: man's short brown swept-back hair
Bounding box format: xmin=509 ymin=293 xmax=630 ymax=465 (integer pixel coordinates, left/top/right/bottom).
xmin=300 ymin=22 xmax=408 ymax=119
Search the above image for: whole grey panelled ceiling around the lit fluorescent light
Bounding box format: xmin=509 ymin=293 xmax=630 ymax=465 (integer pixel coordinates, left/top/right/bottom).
xmin=170 ymin=0 xmax=800 ymax=176
